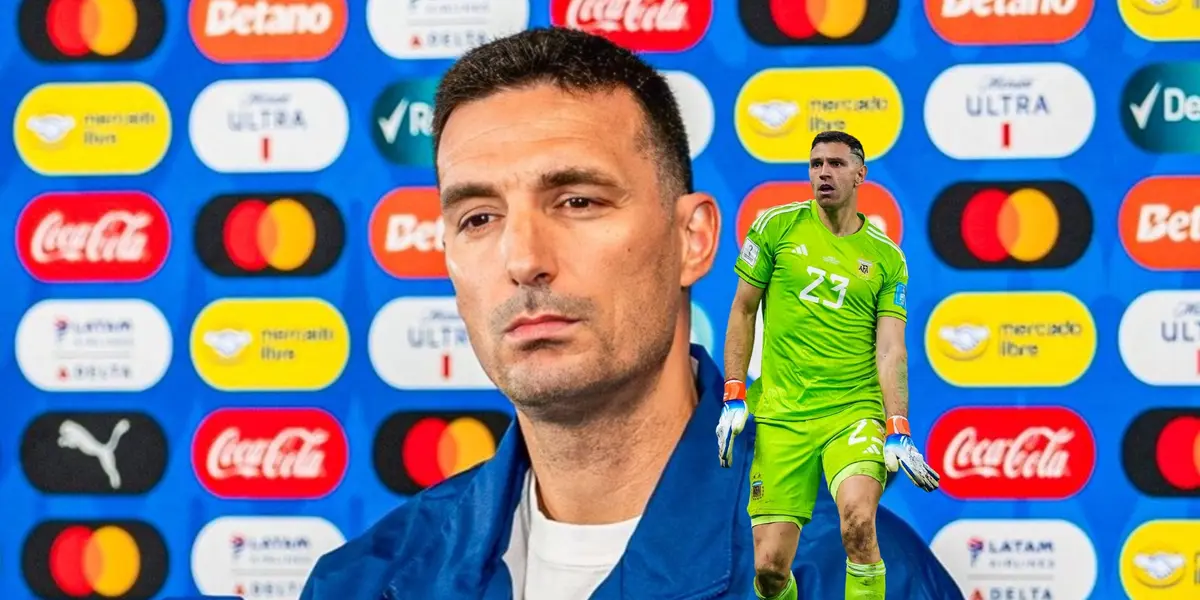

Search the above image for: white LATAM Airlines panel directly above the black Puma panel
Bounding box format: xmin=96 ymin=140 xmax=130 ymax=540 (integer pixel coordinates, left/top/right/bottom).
xmin=16 ymin=300 xmax=172 ymax=391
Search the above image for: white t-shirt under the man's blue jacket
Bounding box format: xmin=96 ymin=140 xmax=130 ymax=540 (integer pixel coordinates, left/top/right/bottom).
xmin=504 ymin=469 xmax=641 ymax=600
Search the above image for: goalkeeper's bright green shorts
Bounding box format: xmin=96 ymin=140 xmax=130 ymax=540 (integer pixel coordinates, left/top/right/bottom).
xmin=748 ymin=402 xmax=887 ymax=527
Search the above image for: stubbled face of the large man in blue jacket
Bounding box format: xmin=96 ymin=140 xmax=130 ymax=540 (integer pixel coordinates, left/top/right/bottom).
xmin=437 ymin=85 xmax=683 ymax=422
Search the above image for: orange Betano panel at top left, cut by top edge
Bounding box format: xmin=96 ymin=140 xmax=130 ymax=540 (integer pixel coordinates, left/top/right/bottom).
xmin=187 ymin=0 xmax=348 ymax=62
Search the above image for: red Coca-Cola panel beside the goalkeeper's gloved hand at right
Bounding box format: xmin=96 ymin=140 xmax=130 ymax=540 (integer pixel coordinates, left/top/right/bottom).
xmin=926 ymin=407 xmax=1096 ymax=500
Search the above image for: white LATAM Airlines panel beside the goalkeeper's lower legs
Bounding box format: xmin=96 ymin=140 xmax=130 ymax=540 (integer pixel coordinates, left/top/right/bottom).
xmin=929 ymin=518 xmax=1097 ymax=600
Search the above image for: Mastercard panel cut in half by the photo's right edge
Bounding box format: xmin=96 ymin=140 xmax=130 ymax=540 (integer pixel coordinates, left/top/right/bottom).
xmin=1121 ymin=408 xmax=1200 ymax=498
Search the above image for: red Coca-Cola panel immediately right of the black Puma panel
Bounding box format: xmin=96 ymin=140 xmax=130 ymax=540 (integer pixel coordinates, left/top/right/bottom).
xmin=192 ymin=408 xmax=349 ymax=499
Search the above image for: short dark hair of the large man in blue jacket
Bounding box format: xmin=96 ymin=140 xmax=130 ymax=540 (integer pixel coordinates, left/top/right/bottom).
xmin=433 ymin=28 xmax=692 ymax=194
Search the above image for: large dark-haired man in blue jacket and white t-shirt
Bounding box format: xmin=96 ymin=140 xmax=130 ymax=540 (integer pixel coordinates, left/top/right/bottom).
xmin=302 ymin=29 xmax=961 ymax=600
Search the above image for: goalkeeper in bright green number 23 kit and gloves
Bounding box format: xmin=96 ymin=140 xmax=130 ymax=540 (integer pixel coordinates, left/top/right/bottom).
xmin=716 ymin=131 xmax=938 ymax=600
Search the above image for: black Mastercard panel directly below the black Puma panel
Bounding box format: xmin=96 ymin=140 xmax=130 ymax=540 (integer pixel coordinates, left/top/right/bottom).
xmin=22 ymin=521 xmax=167 ymax=599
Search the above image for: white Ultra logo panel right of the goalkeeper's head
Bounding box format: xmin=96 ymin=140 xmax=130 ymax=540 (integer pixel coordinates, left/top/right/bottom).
xmin=925 ymin=62 xmax=1096 ymax=160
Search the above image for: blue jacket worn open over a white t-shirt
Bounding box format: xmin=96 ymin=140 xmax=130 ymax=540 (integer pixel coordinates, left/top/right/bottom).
xmin=300 ymin=346 xmax=962 ymax=600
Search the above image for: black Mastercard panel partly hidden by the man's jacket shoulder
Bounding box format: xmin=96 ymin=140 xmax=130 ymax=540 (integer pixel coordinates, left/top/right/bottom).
xmin=374 ymin=412 xmax=512 ymax=496
